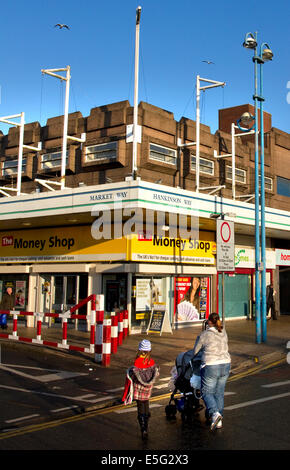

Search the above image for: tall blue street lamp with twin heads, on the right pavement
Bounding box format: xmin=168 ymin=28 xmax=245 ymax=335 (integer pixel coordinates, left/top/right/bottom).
xmin=243 ymin=32 xmax=273 ymax=343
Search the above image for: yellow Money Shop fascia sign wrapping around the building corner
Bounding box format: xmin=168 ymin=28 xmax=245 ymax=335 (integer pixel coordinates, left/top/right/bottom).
xmin=0 ymin=225 xmax=216 ymax=265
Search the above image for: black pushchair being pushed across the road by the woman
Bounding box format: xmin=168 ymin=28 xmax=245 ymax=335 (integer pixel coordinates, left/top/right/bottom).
xmin=165 ymin=349 xmax=204 ymax=421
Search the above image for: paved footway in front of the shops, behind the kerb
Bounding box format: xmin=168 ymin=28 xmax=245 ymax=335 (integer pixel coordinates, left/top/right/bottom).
xmin=0 ymin=315 xmax=290 ymax=411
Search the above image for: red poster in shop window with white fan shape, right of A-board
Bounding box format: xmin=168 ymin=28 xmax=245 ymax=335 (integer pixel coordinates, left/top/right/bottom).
xmin=174 ymin=276 xmax=209 ymax=323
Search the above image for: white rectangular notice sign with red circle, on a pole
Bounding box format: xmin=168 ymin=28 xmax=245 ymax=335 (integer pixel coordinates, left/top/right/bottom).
xmin=216 ymin=220 xmax=235 ymax=271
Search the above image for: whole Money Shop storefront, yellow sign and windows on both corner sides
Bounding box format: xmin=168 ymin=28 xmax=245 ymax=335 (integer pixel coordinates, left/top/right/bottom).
xmin=0 ymin=225 xmax=216 ymax=332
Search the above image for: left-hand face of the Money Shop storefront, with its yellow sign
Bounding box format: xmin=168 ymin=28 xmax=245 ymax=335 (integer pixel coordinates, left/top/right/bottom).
xmin=0 ymin=225 xmax=126 ymax=326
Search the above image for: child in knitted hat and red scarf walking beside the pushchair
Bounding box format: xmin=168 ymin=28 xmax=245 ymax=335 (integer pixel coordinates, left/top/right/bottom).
xmin=122 ymin=339 xmax=159 ymax=439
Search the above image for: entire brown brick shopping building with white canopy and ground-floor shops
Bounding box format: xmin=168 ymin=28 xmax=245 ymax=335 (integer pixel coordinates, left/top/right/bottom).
xmin=0 ymin=101 xmax=290 ymax=333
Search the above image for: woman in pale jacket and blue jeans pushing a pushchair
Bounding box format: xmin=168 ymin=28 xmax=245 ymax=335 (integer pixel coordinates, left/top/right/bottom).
xmin=193 ymin=313 xmax=231 ymax=431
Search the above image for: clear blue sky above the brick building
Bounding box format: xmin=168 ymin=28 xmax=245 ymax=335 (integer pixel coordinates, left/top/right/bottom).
xmin=0 ymin=0 xmax=290 ymax=133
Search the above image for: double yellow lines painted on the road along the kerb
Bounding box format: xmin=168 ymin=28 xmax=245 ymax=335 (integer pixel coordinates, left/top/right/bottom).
xmin=0 ymin=359 xmax=286 ymax=440
